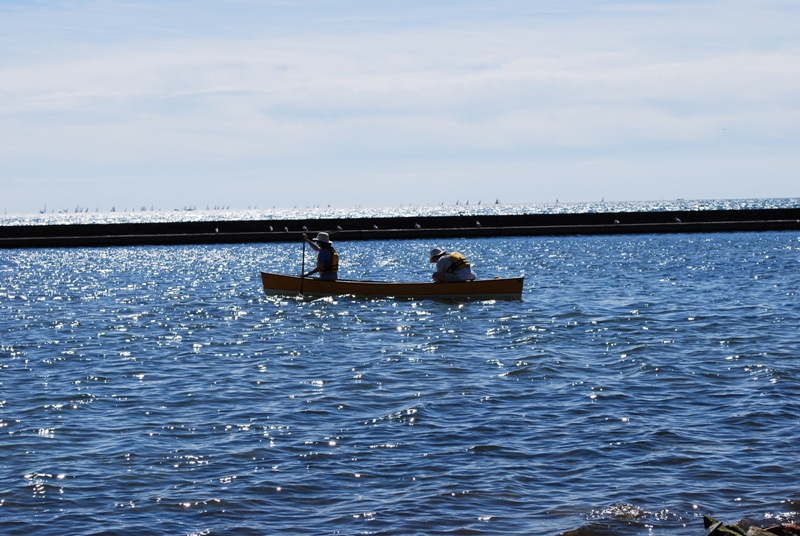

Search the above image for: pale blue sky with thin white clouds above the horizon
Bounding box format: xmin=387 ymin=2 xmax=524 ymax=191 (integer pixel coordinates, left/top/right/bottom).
xmin=0 ymin=0 xmax=800 ymax=213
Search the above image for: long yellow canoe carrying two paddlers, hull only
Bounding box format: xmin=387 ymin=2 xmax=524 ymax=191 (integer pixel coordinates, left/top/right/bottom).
xmin=261 ymin=272 xmax=524 ymax=299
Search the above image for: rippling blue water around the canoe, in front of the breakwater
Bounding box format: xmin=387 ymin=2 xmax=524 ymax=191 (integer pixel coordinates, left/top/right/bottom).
xmin=0 ymin=232 xmax=800 ymax=535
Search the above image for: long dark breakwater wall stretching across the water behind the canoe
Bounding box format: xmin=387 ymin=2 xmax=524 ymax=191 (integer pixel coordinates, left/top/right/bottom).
xmin=0 ymin=208 xmax=800 ymax=248
